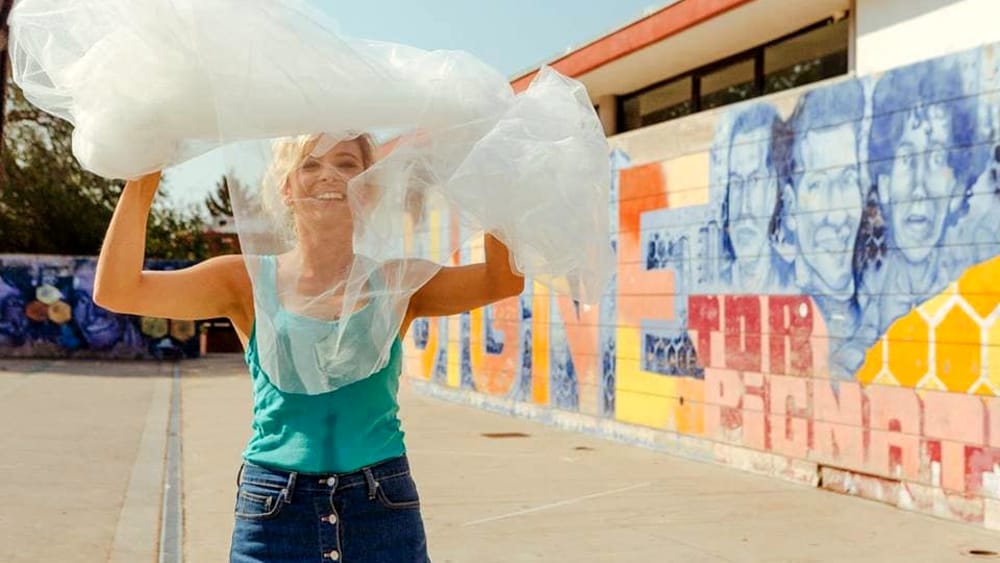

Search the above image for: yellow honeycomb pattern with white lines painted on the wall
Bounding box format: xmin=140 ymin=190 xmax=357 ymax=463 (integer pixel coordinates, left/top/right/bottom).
xmin=858 ymin=257 xmax=1000 ymax=395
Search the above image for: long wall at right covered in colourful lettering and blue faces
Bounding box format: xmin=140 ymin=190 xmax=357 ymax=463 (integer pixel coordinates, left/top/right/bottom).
xmin=406 ymin=41 xmax=1000 ymax=528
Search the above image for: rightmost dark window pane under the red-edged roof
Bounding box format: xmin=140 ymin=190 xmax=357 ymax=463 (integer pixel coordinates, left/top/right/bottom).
xmin=764 ymin=18 xmax=849 ymax=94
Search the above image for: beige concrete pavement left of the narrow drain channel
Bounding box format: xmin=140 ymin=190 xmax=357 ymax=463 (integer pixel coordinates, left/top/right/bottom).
xmin=0 ymin=360 xmax=171 ymax=563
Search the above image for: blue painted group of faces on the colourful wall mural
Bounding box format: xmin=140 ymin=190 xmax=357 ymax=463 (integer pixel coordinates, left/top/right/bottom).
xmin=637 ymin=55 xmax=1000 ymax=384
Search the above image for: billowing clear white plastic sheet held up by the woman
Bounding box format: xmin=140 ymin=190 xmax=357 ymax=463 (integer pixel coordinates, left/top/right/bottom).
xmin=10 ymin=0 xmax=613 ymax=394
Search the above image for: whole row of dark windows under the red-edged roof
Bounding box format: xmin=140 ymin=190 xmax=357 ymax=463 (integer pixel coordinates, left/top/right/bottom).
xmin=618 ymin=18 xmax=849 ymax=132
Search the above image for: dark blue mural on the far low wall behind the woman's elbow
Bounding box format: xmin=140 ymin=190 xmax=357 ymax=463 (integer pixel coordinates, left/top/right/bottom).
xmin=0 ymin=255 xmax=200 ymax=359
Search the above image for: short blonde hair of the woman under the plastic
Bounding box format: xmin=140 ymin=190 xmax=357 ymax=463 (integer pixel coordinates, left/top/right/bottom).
xmin=260 ymin=133 xmax=376 ymax=240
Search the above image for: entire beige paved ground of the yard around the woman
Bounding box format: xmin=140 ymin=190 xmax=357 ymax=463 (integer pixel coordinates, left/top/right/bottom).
xmin=0 ymin=357 xmax=1000 ymax=563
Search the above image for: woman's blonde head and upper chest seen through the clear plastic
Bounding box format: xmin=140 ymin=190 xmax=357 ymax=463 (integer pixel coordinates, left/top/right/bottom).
xmin=234 ymin=134 xmax=422 ymax=394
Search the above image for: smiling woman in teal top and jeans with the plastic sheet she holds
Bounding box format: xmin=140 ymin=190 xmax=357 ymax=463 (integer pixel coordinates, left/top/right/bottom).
xmin=7 ymin=0 xmax=613 ymax=563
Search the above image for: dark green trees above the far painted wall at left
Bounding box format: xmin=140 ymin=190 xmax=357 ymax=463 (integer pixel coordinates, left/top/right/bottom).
xmin=0 ymin=86 xmax=207 ymax=260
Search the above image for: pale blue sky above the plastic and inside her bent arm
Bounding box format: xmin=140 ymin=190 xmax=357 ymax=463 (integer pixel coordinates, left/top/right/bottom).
xmin=165 ymin=0 xmax=673 ymax=212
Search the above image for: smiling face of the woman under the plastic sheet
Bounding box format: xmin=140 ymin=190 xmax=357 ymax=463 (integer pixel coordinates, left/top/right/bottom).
xmin=284 ymin=138 xmax=366 ymax=227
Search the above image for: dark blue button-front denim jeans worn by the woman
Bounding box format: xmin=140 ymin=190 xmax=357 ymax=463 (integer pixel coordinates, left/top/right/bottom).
xmin=229 ymin=456 xmax=430 ymax=563
